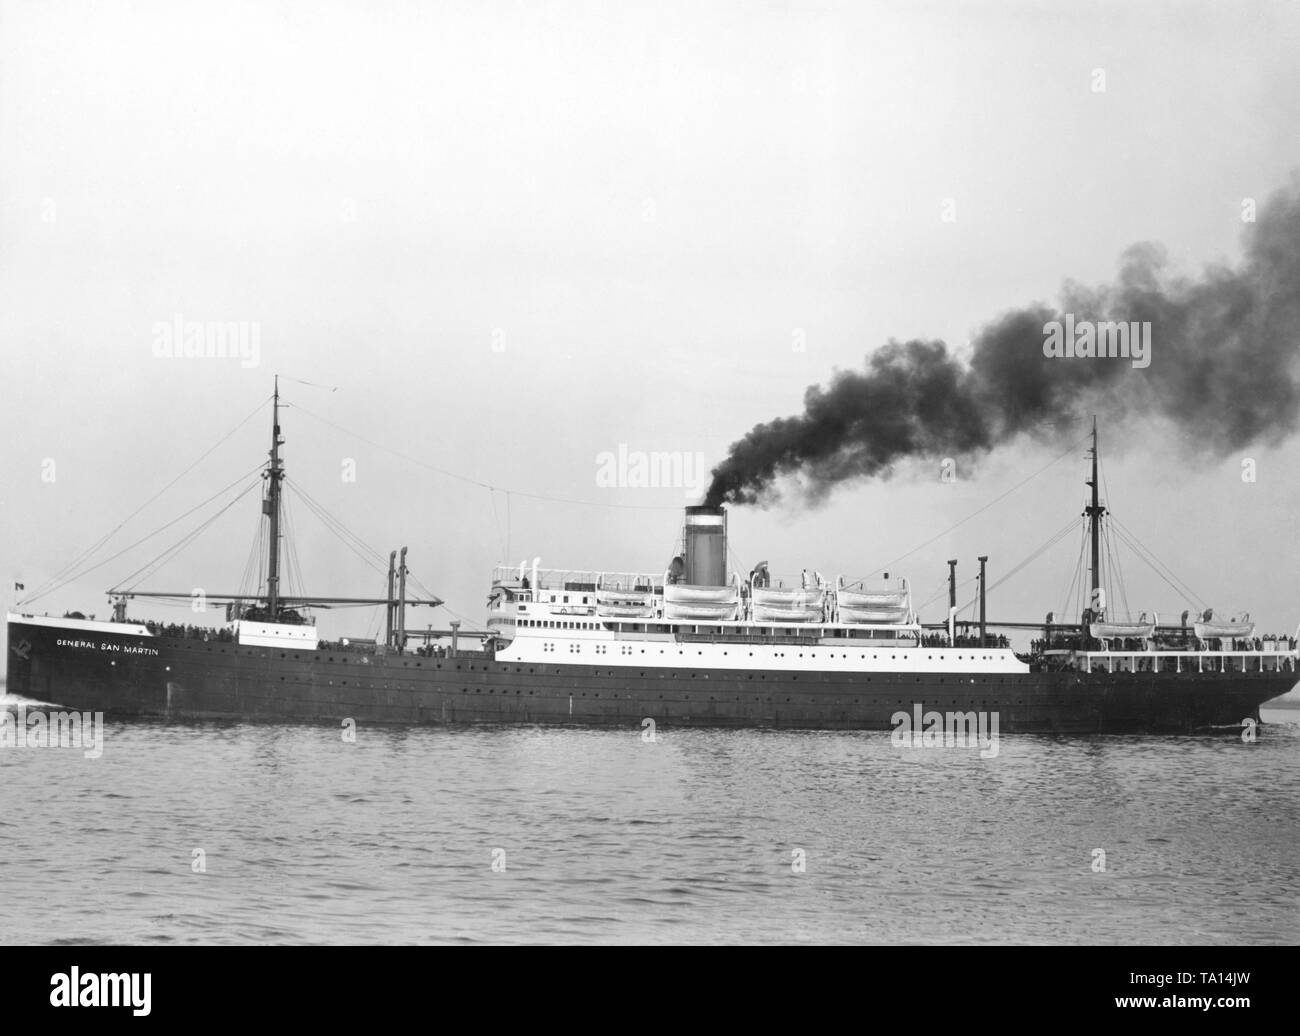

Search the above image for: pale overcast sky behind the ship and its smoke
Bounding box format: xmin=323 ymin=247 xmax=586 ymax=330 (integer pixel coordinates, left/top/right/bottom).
xmin=0 ymin=0 xmax=1300 ymax=647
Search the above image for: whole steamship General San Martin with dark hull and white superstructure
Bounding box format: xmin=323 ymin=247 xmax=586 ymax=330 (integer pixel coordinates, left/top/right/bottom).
xmin=8 ymin=381 xmax=1300 ymax=734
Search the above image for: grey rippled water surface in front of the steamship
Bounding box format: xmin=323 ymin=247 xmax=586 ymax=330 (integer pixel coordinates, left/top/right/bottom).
xmin=0 ymin=697 xmax=1300 ymax=944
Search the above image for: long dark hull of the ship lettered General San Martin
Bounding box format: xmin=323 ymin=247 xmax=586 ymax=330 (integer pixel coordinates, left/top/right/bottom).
xmin=8 ymin=623 xmax=1297 ymax=733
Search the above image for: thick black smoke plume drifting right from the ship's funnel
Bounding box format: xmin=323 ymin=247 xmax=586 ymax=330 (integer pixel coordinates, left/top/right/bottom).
xmin=705 ymin=177 xmax=1300 ymax=506
